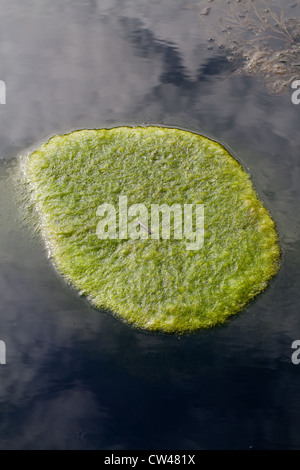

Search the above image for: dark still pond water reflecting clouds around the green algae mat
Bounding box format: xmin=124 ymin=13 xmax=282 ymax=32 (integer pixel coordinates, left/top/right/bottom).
xmin=0 ymin=0 xmax=300 ymax=450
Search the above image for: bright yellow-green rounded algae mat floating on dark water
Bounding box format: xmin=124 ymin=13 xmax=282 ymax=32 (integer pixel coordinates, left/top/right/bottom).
xmin=25 ymin=126 xmax=280 ymax=333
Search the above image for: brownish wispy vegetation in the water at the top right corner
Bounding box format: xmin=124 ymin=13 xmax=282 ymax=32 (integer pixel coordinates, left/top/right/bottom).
xmin=197 ymin=0 xmax=300 ymax=94
